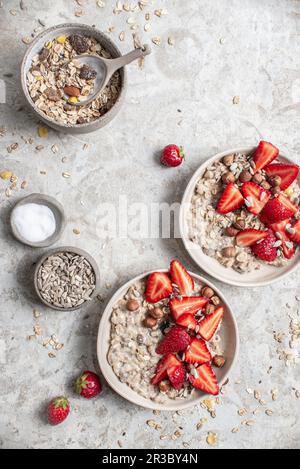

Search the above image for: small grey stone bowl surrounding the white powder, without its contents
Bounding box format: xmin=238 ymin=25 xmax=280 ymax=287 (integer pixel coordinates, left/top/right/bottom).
xmin=10 ymin=194 xmax=66 ymax=248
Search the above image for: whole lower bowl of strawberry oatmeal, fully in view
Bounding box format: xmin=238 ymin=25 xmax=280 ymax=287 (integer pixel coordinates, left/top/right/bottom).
xmin=97 ymin=260 xmax=239 ymax=411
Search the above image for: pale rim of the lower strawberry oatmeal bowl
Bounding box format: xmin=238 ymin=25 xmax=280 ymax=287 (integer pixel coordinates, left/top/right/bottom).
xmin=97 ymin=269 xmax=240 ymax=412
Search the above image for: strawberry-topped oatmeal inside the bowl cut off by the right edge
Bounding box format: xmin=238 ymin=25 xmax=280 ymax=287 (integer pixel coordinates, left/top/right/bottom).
xmin=188 ymin=141 xmax=300 ymax=273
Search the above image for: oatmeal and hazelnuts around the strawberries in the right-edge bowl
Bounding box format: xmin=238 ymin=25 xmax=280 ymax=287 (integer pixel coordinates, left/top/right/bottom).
xmin=187 ymin=144 xmax=300 ymax=273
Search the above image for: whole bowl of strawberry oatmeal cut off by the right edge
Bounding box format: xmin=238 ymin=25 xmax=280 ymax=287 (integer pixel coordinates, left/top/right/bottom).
xmin=180 ymin=141 xmax=300 ymax=287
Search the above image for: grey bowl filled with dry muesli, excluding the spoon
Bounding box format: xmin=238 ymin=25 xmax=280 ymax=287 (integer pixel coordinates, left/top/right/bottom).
xmin=21 ymin=23 xmax=127 ymax=134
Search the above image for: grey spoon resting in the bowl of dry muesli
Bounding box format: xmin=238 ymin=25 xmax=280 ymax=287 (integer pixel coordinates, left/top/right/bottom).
xmin=66 ymin=45 xmax=151 ymax=106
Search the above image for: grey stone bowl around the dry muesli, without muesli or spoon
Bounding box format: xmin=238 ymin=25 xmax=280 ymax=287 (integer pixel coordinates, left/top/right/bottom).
xmin=21 ymin=23 xmax=127 ymax=134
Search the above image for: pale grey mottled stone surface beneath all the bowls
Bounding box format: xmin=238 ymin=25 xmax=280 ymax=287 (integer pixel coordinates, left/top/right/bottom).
xmin=0 ymin=0 xmax=300 ymax=448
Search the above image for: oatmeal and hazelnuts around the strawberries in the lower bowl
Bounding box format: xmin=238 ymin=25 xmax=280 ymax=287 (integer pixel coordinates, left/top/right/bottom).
xmin=108 ymin=260 xmax=225 ymax=403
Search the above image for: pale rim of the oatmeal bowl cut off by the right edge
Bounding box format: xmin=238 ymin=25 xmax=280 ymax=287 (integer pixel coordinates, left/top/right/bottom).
xmin=179 ymin=145 xmax=300 ymax=288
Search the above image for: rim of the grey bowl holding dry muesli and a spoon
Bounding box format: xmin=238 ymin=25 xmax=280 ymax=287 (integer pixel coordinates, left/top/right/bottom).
xmin=21 ymin=23 xmax=127 ymax=130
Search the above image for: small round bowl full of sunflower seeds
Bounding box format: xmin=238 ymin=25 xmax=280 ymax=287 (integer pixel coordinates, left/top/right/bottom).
xmin=34 ymin=246 xmax=100 ymax=311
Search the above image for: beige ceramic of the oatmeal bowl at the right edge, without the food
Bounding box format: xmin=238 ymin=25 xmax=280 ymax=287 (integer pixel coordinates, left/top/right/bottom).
xmin=179 ymin=147 xmax=300 ymax=287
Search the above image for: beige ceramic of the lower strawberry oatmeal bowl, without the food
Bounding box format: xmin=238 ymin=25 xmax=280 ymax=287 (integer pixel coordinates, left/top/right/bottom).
xmin=97 ymin=269 xmax=239 ymax=412
